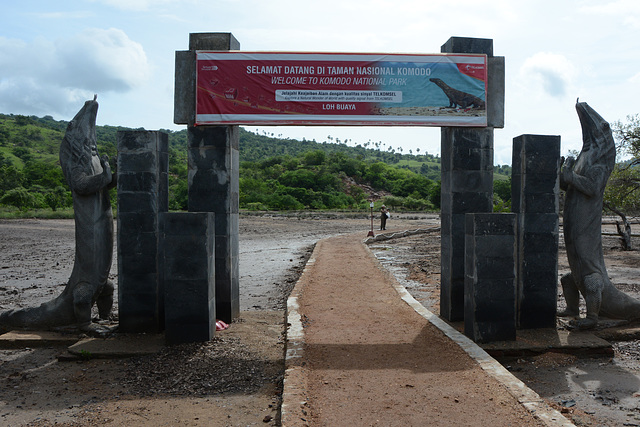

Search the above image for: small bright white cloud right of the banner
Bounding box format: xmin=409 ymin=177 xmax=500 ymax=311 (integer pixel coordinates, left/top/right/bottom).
xmin=520 ymin=52 xmax=575 ymax=98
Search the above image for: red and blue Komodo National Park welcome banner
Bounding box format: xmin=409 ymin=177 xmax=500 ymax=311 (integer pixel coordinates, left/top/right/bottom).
xmin=195 ymin=51 xmax=487 ymax=126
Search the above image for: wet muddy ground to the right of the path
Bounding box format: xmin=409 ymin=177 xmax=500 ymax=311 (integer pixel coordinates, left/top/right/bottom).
xmin=370 ymin=219 xmax=640 ymax=426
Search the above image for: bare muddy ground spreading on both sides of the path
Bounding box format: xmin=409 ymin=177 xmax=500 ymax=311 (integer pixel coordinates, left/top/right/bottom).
xmin=0 ymin=215 xmax=640 ymax=426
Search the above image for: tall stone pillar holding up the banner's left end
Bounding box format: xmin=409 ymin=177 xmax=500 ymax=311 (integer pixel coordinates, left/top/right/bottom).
xmin=173 ymin=33 xmax=240 ymax=322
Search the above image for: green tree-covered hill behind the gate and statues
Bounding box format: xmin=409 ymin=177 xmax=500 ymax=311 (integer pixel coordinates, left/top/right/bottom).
xmin=0 ymin=114 xmax=510 ymax=216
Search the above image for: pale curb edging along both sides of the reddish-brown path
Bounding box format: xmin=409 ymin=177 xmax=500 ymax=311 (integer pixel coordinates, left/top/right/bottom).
xmin=281 ymin=236 xmax=575 ymax=427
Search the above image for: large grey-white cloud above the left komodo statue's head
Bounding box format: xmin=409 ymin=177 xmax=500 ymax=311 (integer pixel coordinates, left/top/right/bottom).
xmin=0 ymin=28 xmax=150 ymax=114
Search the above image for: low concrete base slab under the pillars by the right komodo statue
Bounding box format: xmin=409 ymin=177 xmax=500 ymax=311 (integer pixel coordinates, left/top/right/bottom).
xmin=481 ymin=329 xmax=613 ymax=358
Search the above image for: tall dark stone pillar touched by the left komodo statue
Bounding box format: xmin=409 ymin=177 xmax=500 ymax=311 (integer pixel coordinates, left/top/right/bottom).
xmin=117 ymin=131 xmax=169 ymax=333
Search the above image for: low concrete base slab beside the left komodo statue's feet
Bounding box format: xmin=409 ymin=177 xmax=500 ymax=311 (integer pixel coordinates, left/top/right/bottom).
xmin=69 ymin=334 xmax=164 ymax=359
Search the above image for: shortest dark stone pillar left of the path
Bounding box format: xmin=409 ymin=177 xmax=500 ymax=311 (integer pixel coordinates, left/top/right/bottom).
xmin=160 ymin=212 xmax=216 ymax=345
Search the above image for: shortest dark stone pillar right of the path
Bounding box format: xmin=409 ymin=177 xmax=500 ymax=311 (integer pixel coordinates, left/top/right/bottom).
xmin=464 ymin=213 xmax=517 ymax=342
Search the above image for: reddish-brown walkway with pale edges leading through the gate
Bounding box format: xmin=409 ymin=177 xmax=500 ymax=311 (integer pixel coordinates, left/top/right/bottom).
xmin=282 ymin=230 xmax=573 ymax=426
